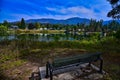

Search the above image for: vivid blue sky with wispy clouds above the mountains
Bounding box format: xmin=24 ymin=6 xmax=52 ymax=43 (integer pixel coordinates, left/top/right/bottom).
xmin=0 ymin=0 xmax=111 ymax=22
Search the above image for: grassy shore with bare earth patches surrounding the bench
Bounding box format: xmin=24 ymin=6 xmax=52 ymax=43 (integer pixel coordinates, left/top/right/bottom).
xmin=0 ymin=37 xmax=120 ymax=80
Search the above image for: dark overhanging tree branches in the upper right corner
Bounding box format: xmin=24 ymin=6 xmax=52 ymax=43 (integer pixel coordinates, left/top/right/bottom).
xmin=107 ymin=0 xmax=120 ymax=19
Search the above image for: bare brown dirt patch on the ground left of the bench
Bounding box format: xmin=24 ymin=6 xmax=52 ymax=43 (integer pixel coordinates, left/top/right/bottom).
xmin=6 ymin=62 xmax=39 ymax=80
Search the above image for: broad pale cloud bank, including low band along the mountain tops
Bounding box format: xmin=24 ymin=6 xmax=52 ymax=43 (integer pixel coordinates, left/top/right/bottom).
xmin=9 ymin=6 xmax=111 ymax=20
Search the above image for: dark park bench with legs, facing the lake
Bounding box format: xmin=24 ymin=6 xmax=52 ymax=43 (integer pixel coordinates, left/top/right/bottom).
xmin=46 ymin=52 xmax=103 ymax=80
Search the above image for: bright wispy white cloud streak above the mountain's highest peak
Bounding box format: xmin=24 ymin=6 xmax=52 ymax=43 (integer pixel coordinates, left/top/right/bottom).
xmin=46 ymin=6 xmax=96 ymax=18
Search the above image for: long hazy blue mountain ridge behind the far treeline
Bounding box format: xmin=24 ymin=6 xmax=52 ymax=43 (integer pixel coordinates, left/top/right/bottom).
xmin=26 ymin=17 xmax=90 ymax=24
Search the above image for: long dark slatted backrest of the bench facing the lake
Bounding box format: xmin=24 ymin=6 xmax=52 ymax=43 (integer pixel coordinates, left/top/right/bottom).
xmin=52 ymin=53 xmax=101 ymax=68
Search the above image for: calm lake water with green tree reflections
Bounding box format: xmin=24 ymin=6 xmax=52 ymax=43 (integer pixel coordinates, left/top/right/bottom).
xmin=0 ymin=33 xmax=86 ymax=42
